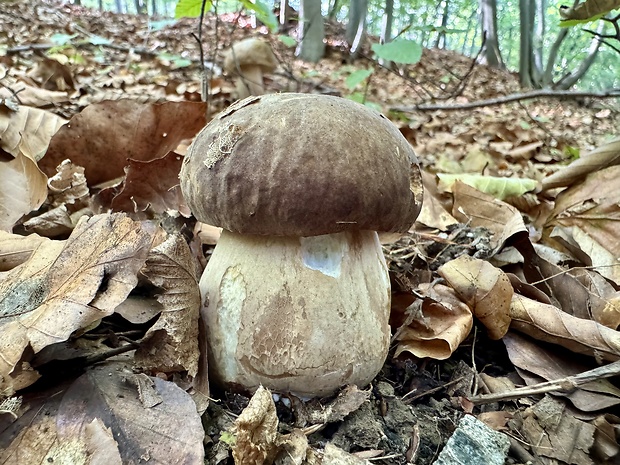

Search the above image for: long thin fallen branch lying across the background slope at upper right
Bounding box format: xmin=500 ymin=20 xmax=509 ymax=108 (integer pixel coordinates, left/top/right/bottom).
xmin=390 ymin=89 xmax=620 ymax=113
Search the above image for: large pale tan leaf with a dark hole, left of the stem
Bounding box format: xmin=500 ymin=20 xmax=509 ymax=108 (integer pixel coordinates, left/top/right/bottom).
xmin=0 ymin=214 xmax=155 ymax=390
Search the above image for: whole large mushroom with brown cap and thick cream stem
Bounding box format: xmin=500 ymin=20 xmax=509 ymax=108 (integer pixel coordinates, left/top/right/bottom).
xmin=180 ymin=93 xmax=422 ymax=398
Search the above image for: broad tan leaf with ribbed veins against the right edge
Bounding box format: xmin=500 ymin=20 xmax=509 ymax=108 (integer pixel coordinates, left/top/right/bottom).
xmin=545 ymin=165 xmax=620 ymax=284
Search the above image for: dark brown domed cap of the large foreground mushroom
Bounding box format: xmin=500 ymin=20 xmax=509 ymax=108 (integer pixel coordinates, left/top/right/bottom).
xmin=180 ymin=93 xmax=422 ymax=236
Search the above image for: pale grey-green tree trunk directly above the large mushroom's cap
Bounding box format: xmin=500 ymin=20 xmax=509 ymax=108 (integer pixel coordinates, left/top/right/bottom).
xmin=296 ymin=0 xmax=325 ymax=63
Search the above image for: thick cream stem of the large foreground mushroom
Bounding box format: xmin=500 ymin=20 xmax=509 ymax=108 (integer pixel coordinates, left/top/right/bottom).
xmin=200 ymin=231 xmax=390 ymax=397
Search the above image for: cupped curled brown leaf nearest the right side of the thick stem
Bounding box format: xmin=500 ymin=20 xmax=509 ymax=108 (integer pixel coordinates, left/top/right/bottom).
xmin=394 ymin=284 xmax=473 ymax=360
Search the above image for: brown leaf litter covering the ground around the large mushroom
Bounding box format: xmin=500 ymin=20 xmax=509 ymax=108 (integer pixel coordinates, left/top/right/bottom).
xmin=0 ymin=2 xmax=620 ymax=464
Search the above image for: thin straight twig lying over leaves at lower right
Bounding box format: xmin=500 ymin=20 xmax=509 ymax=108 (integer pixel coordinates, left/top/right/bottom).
xmin=469 ymin=360 xmax=620 ymax=404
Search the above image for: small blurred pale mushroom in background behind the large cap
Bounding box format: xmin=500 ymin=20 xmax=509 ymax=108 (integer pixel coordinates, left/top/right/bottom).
xmin=224 ymin=38 xmax=278 ymax=99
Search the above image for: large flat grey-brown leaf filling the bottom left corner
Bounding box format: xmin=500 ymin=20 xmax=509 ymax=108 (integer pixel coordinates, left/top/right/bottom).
xmin=0 ymin=363 xmax=204 ymax=465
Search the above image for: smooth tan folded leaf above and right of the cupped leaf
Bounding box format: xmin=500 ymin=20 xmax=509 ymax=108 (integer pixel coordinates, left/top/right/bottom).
xmin=438 ymin=255 xmax=513 ymax=339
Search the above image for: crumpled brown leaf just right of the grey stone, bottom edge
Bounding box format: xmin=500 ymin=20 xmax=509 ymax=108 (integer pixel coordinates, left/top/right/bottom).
xmin=521 ymin=396 xmax=594 ymax=465
